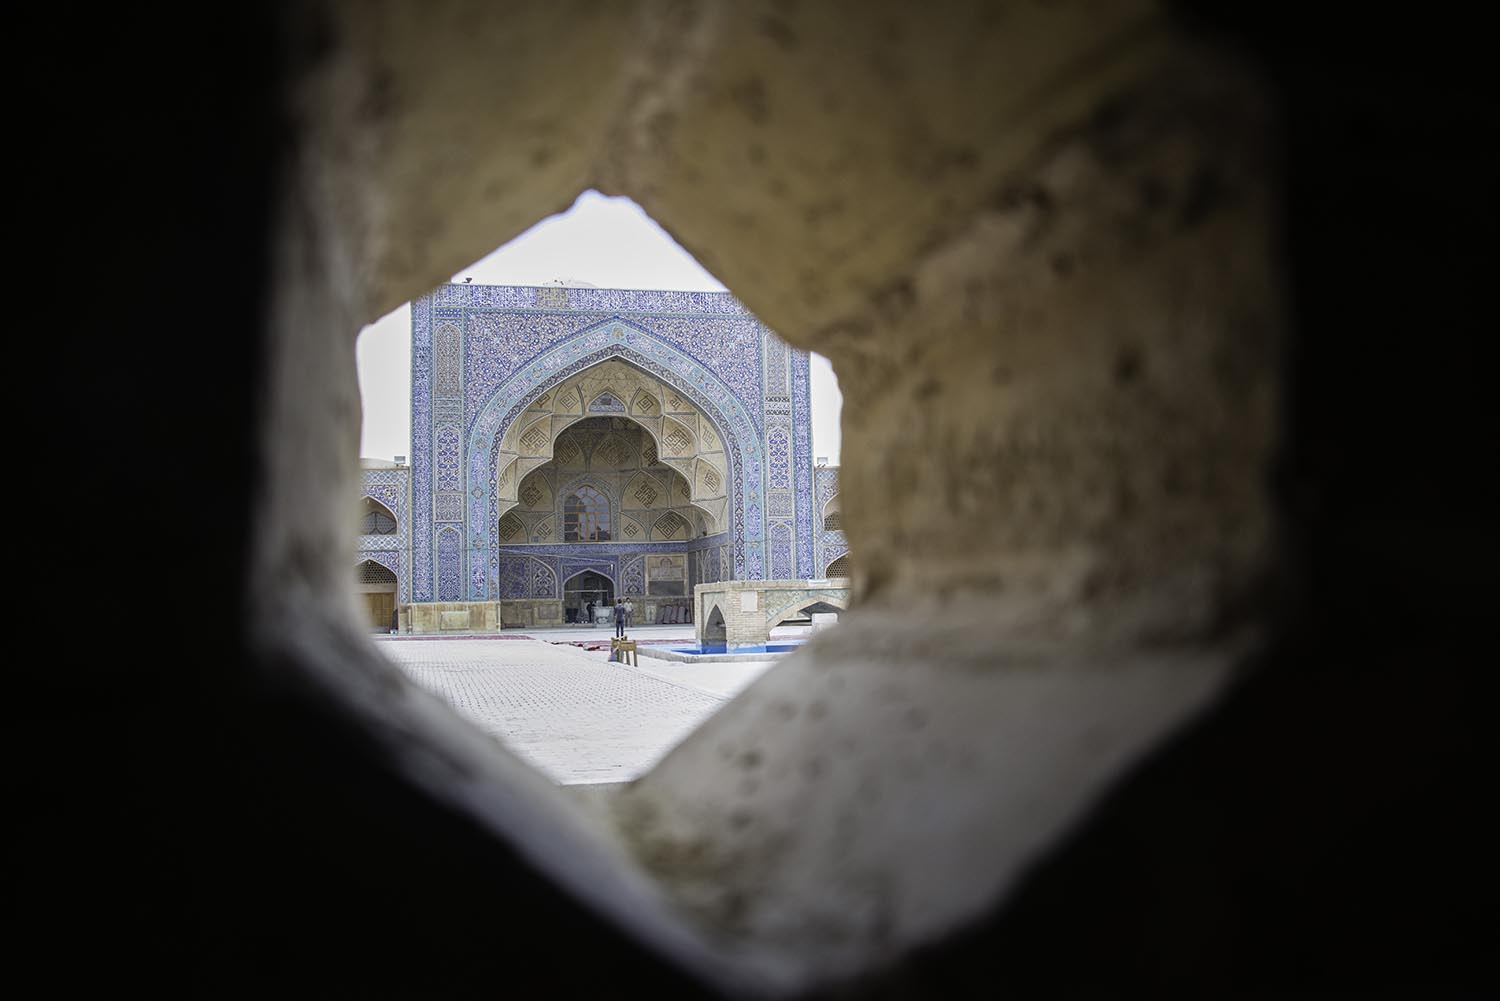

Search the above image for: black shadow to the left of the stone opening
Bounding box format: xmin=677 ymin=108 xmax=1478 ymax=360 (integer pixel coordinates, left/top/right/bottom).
xmin=20 ymin=3 xmax=714 ymax=996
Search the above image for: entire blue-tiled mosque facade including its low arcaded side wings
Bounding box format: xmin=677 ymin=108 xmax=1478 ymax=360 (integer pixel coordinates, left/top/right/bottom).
xmin=357 ymin=284 xmax=848 ymax=632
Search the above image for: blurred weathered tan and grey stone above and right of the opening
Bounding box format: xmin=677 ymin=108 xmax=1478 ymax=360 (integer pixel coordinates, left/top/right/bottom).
xmin=252 ymin=3 xmax=1283 ymax=990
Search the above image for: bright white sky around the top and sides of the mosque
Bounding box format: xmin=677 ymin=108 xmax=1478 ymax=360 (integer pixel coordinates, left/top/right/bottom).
xmin=356 ymin=191 xmax=843 ymax=464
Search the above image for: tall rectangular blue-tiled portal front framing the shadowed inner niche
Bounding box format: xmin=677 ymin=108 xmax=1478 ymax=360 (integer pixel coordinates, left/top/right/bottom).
xmin=411 ymin=285 xmax=819 ymax=612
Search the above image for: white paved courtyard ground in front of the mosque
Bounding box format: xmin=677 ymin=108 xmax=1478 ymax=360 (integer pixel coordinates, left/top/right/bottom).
xmin=377 ymin=626 xmax=795 ymax=785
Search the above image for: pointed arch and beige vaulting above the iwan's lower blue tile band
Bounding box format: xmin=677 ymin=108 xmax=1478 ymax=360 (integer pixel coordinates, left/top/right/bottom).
xmin=468 ymin=346 xmax=765 ymax=599
